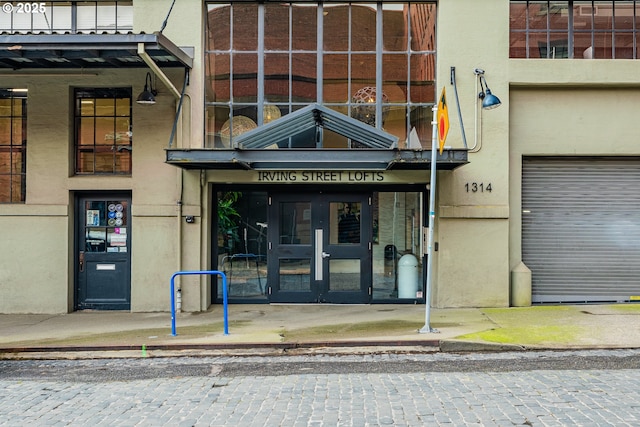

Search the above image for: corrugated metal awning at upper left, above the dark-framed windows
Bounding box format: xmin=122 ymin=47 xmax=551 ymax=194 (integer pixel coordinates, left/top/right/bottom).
xmin=0 ymin=32 xmax=193 ymax=70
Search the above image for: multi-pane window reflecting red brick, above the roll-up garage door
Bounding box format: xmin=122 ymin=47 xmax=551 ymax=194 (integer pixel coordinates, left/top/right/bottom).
xmin=509 ymin=0 xmax=640 ymax=59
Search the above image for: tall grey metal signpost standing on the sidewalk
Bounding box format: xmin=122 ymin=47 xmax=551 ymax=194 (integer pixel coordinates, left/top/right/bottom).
xmin=420 ymin=104 xmax=438 ymax=334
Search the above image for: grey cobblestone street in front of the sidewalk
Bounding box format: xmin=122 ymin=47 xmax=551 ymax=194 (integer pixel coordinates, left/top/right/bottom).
xmin=0 ymin=351 xmax=640 ymax=426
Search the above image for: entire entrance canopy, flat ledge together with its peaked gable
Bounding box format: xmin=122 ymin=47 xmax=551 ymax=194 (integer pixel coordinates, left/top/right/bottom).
xmin=166 ymin=104 xmax=467 ymax=171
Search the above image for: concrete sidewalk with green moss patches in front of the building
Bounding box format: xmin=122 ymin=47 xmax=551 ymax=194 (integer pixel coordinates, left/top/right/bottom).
xmin=0 ymin=304 xmax=640 ymax=358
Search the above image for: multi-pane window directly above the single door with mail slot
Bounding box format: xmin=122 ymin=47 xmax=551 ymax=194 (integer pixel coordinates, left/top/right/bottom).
xmin=74 ymin=88 xmax=132 ymax=175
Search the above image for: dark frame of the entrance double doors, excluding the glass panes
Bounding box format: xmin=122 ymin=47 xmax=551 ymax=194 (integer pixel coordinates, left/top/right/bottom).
xmin=267 ymin=191 xmax=372 ymax=304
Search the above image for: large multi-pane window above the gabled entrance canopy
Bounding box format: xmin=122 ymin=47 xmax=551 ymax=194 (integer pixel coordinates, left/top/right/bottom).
xmin=205 ymin=2 xmax=436 ymax=148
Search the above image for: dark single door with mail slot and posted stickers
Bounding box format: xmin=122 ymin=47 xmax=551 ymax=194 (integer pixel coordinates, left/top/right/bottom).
xmin=75 ymin=193 xmax=131 ymax=310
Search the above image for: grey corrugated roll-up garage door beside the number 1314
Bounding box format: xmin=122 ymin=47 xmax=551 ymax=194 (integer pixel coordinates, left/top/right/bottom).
xmin=522 ymin=157 xmax=640 ymax=302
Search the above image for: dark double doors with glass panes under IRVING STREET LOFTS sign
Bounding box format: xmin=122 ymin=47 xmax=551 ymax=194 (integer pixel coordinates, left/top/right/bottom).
xmin=267 ymin=192 xmax=372 ymax=304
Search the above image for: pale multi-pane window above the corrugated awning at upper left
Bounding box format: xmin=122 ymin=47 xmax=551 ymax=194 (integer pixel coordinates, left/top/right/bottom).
xmin=0 ymin=0 xmax=133 ymax=34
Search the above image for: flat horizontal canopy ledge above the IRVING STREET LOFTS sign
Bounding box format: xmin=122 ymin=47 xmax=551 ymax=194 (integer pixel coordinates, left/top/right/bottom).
xmin=166 ymin=148 xmax=468 ymax=170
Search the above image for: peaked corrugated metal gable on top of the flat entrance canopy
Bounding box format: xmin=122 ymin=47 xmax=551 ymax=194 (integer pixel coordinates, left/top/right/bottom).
xmin=234 ymin=104 xmax=398 ymax=149
